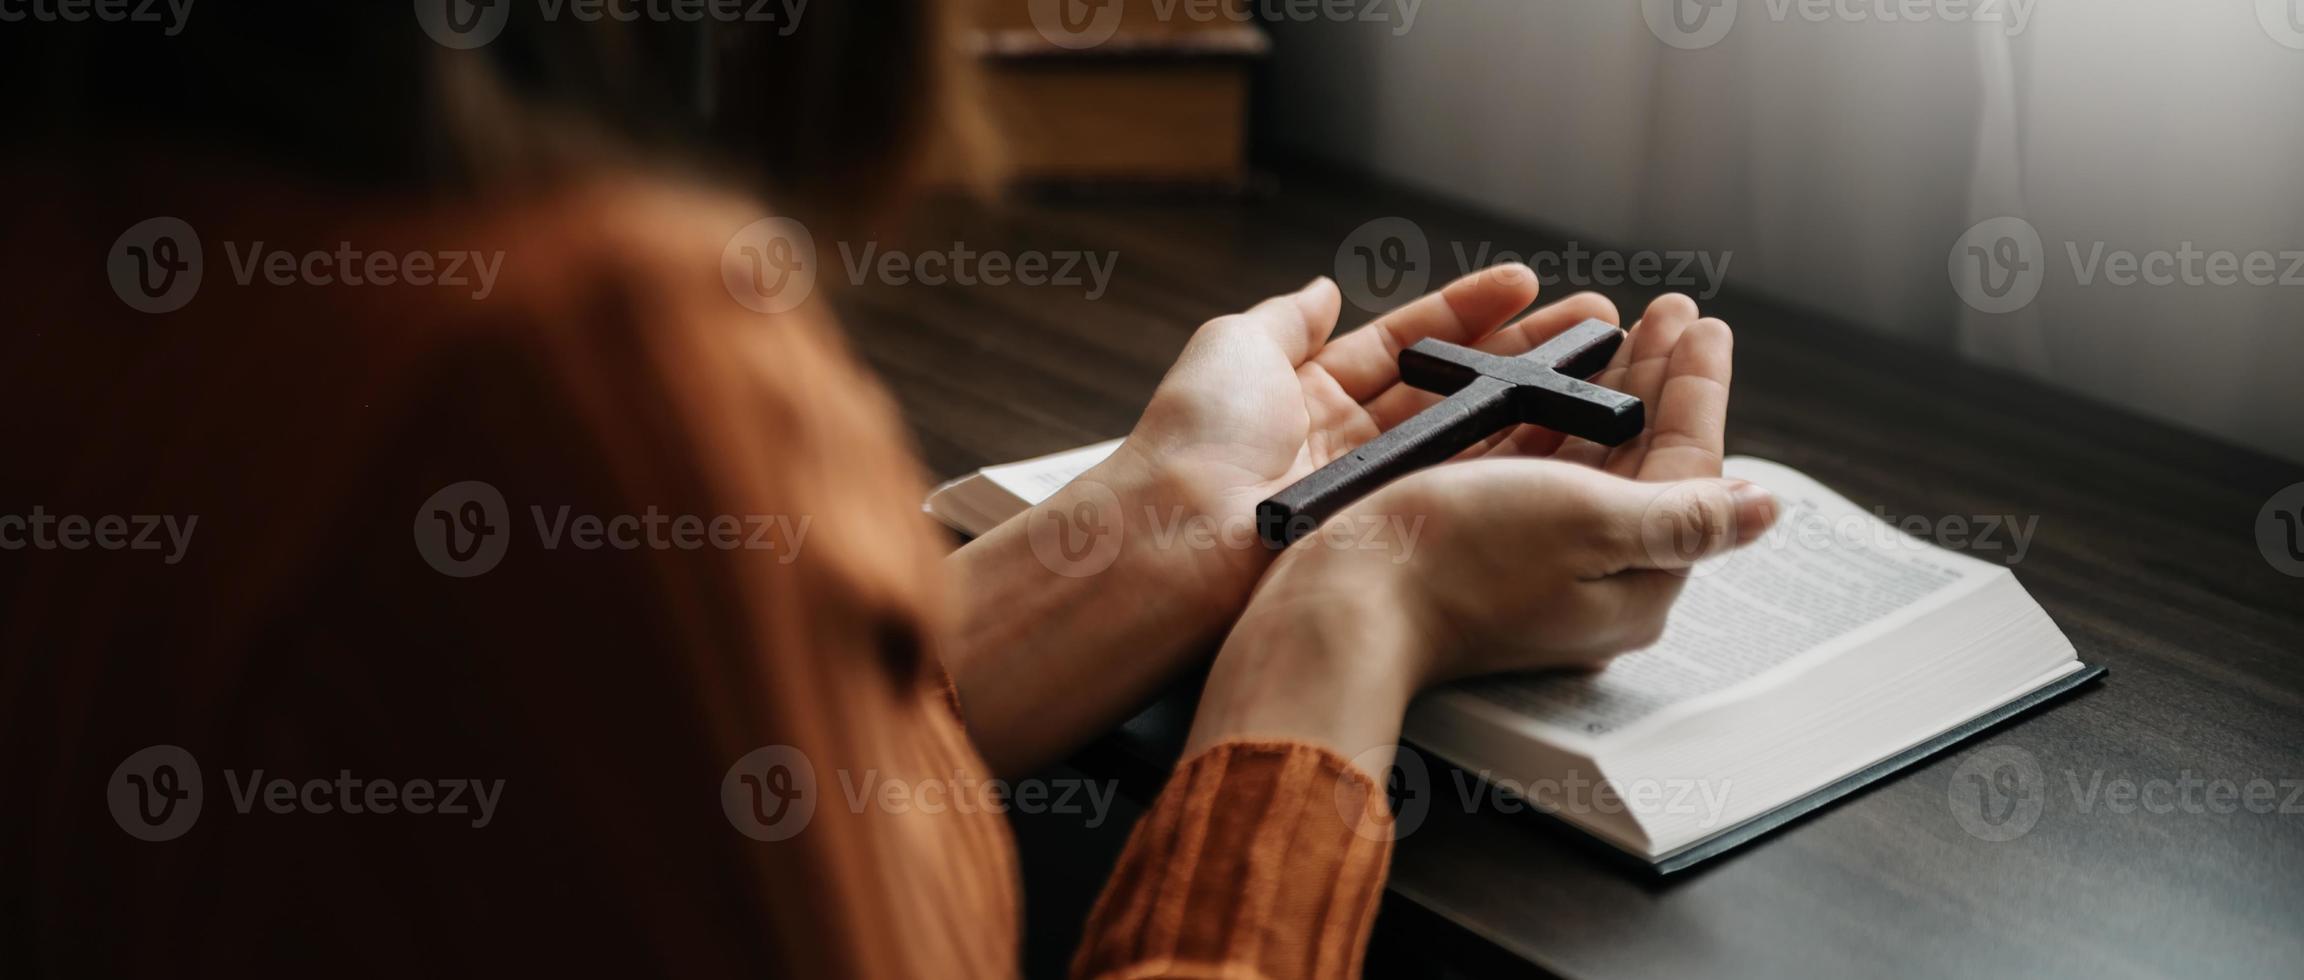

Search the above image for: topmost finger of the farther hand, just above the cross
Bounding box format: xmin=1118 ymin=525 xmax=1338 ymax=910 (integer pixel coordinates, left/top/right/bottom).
xmin=1311 ymin=263 xmax=1537 ymax=401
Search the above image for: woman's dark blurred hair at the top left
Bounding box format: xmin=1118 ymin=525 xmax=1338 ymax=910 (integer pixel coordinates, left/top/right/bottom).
xmin=0 ymin=0 xmax=988 ymax=230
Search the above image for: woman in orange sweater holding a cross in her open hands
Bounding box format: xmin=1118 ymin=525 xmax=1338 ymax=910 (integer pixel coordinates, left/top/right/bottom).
xmin=0 ymin=2 xmax=1774 ymax=978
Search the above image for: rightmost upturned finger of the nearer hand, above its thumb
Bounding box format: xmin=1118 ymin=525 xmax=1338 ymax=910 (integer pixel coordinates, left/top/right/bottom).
xmin=1610 ymin=318 xmax=1735 ymax=480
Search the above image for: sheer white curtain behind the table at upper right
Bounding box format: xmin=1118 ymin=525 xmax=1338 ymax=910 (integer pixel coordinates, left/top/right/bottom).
xmin=1267 ymin=0 xmax=2304 ymax=459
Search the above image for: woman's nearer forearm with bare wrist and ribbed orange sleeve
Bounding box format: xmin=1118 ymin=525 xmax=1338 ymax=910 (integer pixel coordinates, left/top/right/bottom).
xmin=1074 ymin=558 xmax=1424 ymax=978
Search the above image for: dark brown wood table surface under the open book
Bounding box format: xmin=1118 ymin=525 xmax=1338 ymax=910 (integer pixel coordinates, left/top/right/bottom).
xmin=825 ymin=163 xmax=2304 ymax=978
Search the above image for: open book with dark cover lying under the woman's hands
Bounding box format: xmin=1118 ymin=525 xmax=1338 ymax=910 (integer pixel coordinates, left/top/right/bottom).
xmin=926 ymin=443 xmax=2104 ymax=872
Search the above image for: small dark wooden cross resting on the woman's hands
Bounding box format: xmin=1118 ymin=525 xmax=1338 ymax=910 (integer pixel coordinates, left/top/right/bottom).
xmin=1256 ymin=321 xmax=1645 ymax=549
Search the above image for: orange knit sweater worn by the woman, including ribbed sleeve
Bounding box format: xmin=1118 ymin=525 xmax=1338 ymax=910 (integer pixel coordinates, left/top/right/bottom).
xmin=0 ymin=175 xmax=1389 ymax=978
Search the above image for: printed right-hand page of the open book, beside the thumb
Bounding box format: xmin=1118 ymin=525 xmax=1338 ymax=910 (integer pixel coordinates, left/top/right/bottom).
xmin=1456 ymin=457 xmax=2000 ymax=738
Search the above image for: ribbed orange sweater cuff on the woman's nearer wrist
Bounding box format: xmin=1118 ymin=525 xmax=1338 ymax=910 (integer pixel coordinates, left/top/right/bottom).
xmin=1071 ymin=740 xmax=1392 ymax=978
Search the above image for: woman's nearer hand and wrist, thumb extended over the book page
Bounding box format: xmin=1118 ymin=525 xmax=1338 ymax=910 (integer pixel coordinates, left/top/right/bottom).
xmin=1193 ymin=297 xmax=1776 ymax=770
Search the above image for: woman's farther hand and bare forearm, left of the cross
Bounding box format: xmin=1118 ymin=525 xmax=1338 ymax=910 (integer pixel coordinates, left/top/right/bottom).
xmin=945 ymin=265 xmax=1615 ymax=772
